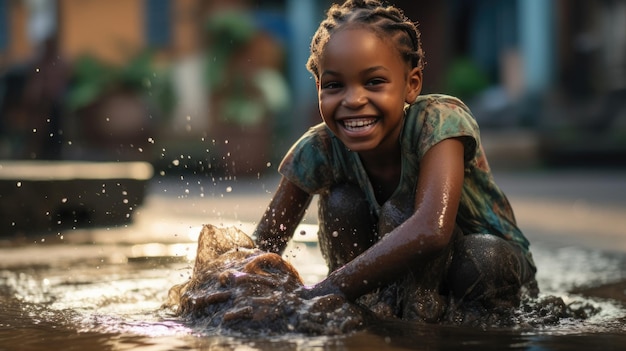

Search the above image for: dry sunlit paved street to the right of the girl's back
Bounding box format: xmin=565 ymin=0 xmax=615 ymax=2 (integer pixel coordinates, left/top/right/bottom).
xmin=496 ymin=170 xmax=626 ymax=253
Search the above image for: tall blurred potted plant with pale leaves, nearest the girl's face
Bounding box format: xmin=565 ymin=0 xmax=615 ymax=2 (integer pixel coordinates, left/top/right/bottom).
xmin=205 ymin=11 xmax=289 ymax=175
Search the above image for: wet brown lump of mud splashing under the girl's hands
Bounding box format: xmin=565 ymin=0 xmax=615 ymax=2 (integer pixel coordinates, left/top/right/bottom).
xmin=166 ymin=225 xmax=371 ymax=335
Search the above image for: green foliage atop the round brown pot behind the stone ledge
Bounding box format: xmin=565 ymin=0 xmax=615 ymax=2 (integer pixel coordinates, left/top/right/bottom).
xmin=65 ymin=51 xmax=176 ymax=116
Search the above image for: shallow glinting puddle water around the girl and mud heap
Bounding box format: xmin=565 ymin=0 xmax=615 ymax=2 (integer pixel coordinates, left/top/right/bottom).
xmin=0 ymin=234 xmax=626 ymax=350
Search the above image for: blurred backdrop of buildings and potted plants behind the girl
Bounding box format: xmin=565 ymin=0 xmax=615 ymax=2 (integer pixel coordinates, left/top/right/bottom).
xmin=0 ymin=0 xmax=626 ymax=175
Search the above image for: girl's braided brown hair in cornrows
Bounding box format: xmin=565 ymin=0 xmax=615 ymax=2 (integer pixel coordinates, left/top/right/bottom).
xmin=306 ymin=0 xmax=424 ymax=79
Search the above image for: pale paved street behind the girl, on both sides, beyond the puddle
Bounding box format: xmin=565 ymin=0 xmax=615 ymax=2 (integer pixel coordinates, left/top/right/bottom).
xmin=41 ymin=170 xmax=626 ymax=252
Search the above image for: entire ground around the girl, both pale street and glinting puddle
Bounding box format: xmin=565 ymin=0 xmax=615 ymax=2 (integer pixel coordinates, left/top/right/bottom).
xmin=0 ymin=170 xmax=626 ymax=350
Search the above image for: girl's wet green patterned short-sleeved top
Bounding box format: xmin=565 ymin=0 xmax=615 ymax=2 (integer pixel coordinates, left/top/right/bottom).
xmin=279 ymin=95 xmax=534 ymax=266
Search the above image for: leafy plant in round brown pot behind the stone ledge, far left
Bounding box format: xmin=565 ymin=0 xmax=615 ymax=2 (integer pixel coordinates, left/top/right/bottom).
xmin=66 ymin=51 xmax=174 ymax=160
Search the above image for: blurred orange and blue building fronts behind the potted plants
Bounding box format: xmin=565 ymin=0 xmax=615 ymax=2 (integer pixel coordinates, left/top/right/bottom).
xmin=0 ymin=0 xmax=626 ymax=167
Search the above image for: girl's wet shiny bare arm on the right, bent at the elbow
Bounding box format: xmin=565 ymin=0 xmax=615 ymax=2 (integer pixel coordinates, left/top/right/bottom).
xmin=303 ymin=139 xmax=464 ymax=300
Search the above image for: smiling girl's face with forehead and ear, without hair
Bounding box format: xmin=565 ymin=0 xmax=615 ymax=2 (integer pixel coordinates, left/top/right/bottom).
xmin=317 ymin=28 xmax=422 ymax=152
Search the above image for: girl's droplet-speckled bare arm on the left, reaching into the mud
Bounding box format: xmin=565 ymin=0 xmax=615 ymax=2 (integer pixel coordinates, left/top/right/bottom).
xmin=253 ymin=177 xmax=313 ymax=254
